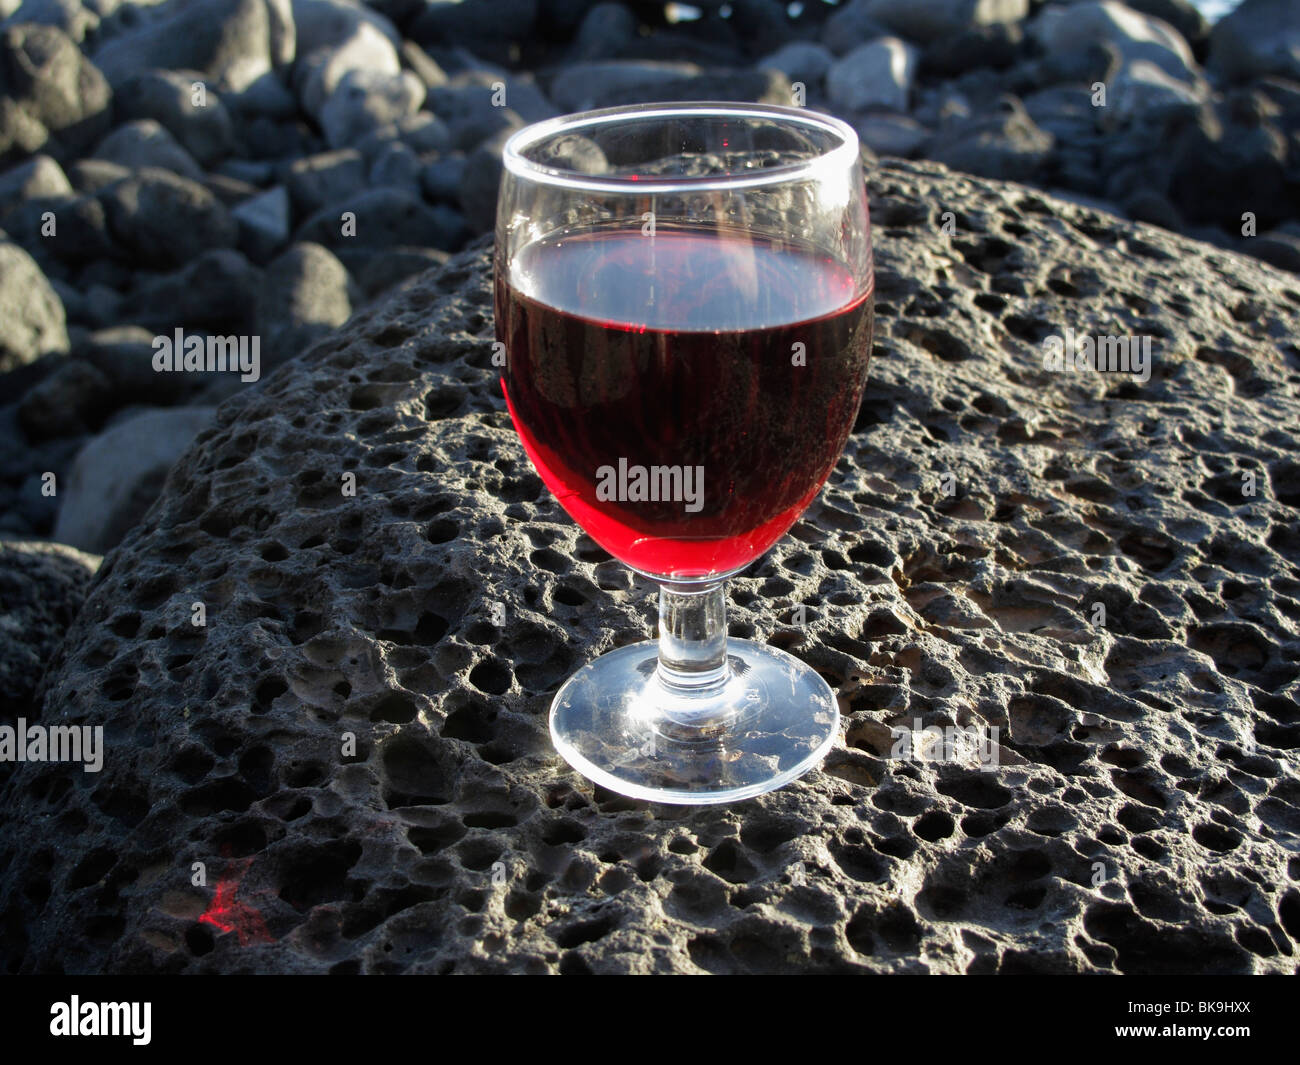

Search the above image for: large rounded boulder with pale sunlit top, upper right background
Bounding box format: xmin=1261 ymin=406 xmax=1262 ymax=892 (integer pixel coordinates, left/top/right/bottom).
xmin=1030 ymin=0 xmax=1199 ymax=81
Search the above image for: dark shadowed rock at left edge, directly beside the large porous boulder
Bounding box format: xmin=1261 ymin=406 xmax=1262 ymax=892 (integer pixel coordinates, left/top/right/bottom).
xmin=0 ymin=540 xmax=100 ymax=724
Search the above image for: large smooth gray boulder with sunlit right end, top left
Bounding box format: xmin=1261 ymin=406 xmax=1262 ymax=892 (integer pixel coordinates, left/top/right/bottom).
xmin=95 ymin=0 xmax=291 ymax=92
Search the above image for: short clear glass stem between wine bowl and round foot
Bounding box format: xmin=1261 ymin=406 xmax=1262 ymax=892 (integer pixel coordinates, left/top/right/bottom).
xmin=658 ymin=581 xmax=728 ymax=698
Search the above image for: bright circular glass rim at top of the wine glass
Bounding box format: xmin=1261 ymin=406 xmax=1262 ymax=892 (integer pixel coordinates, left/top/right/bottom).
xmin=502 ymin=100 xmax=861 ymax=192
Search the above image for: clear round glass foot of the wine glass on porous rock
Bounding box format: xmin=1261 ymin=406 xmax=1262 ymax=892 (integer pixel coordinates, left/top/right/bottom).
xmin=551 ymin=638 xmax=840 ymax=805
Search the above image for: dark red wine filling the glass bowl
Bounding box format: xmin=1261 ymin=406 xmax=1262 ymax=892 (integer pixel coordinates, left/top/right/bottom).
xmin=495 ymin=226 xmax=872 ymax=577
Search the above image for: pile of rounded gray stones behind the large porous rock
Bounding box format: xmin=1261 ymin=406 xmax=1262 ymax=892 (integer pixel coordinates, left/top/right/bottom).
xmin=0 ymin=0 xmax=1300 ymax=553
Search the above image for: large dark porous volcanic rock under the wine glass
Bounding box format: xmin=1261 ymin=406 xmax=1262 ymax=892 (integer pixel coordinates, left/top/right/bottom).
xmin=0 ymin=156 xmax=1300 ymax=973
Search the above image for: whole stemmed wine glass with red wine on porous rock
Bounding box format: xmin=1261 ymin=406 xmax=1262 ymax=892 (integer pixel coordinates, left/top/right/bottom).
xmin=494 ymin=103 xmax=874 ymax=804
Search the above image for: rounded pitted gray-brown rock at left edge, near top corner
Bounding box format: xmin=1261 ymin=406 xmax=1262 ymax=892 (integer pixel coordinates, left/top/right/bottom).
xmin=0 ymin=25 xmax=112 ymax=163
